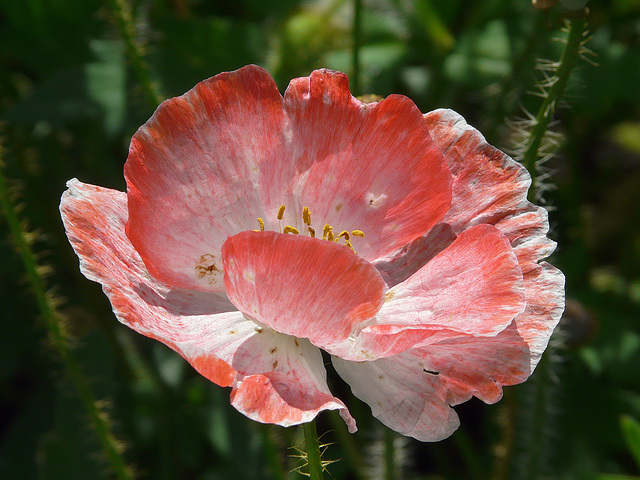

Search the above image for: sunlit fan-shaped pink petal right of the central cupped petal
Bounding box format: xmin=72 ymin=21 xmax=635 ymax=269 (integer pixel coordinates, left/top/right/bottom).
xmin=376 ymin=225 xmax=525 ymax=336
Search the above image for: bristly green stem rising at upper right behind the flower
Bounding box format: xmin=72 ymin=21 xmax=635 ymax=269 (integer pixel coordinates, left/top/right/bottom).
xmin=522 ymin=13 xmax=587 ymax=198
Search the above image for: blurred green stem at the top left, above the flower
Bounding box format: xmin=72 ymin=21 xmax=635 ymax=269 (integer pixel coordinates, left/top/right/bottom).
xmin=108 ymin=0 xmax=162 ymax=110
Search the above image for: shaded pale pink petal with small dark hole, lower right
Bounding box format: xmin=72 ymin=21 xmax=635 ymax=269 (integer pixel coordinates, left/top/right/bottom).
xmin=332 ymin=324 xmax=530 ymax=441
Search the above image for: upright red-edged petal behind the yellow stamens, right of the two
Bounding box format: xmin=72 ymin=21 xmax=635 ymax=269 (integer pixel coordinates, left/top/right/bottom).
xmin=283 ymin=70 xmax=451 ymax=260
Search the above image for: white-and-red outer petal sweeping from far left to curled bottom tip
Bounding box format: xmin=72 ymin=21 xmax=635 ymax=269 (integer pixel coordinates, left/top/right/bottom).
xmin=60 ymin=180 xmax=355 ymax=430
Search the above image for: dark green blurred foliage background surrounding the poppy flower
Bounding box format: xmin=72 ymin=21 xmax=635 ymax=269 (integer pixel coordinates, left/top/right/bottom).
xmin=0 ymin=0 xmax=640 ymax=480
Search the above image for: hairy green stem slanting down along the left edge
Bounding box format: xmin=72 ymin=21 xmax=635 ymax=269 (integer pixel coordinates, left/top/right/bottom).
xmin=0 ymin=144 xmax=133 ymax=480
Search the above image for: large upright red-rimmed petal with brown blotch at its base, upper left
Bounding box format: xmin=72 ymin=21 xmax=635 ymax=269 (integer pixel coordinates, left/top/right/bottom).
xmin=125 ymin=65 xmax=284 ymax=291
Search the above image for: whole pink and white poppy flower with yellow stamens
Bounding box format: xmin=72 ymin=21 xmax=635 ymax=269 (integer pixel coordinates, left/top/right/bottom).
xmin=60 ymin=66 xmax=564 ymax=441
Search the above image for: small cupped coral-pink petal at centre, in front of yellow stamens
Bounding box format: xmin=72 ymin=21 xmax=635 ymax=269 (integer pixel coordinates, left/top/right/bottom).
xmin=222 ymin=231 xmax=386 ymax=349
